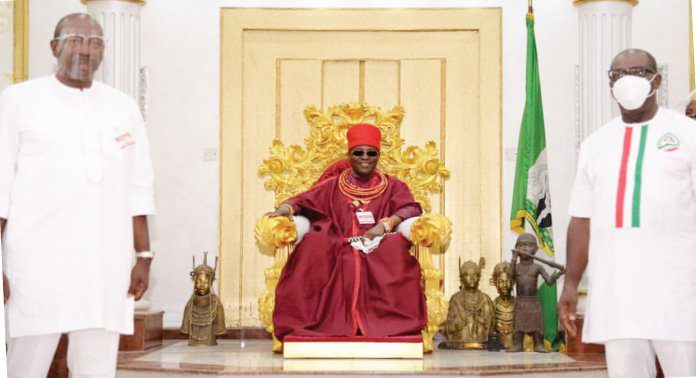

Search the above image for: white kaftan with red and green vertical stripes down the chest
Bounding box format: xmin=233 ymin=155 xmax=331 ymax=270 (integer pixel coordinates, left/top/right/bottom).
xmin=570 ymin=108 xmax=696 ymax=343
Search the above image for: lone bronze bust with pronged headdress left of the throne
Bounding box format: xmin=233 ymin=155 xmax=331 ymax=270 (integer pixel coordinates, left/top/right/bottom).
xmin=180 ymin=252 xmax=227 ymax=346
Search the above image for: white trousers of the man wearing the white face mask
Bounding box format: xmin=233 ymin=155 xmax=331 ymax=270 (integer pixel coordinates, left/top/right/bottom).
xmin=604 ymin=339 xmax=696 ymax=378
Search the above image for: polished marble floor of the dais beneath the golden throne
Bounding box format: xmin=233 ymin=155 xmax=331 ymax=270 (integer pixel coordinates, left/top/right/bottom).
xmin=117 ymin=340 xmax=606 ymax=378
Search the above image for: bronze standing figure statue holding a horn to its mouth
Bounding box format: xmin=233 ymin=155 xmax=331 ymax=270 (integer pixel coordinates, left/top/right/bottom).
xmin=508 ymin=234 xmax=565 ymax=353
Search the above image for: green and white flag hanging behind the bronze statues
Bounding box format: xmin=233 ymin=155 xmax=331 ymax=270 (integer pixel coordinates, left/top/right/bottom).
xmin=510 ymin=12 xmax=561 ymax=350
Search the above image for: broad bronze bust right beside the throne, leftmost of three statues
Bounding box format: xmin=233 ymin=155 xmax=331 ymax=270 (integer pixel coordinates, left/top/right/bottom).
xmin=439 ymin=257 xmax=495 ymax=349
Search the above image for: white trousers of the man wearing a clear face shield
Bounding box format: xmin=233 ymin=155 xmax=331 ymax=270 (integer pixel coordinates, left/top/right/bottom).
xmin=7 ymin=329 xmax=119 ymax=378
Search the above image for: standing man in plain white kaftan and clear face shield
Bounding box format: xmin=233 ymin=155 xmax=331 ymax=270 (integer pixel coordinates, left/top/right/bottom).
xmin=0 ymin=14 xmax=155 ymax=377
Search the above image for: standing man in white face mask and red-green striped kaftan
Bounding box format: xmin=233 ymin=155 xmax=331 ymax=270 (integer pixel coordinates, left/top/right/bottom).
xmin=558 ymin=49 xmax=696 ymax=378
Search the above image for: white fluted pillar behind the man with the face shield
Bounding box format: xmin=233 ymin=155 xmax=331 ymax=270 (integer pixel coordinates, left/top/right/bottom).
xmin=83 ymin=0 xmax=145 ymax=101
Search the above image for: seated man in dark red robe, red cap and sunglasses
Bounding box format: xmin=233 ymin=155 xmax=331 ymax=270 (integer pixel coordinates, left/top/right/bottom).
xmin=269 ymin=124 xmax=426 ymax=341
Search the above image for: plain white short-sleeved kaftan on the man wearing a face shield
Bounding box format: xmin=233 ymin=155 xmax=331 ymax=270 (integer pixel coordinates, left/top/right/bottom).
xmin=0 ymin=76 xmax=155 ymax=337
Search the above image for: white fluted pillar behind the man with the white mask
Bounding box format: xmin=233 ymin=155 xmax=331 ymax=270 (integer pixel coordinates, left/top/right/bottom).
xmin=573 ymin=0 xmax=638 ymax=145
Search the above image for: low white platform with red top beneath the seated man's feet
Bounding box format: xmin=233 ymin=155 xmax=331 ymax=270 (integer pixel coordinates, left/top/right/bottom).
xmin=283 ymin=335 xmax=423 ymax=359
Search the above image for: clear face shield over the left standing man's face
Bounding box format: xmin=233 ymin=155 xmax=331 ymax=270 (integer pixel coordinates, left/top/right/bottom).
xmin=54 ymin=28 xmax=106 ymax=83
